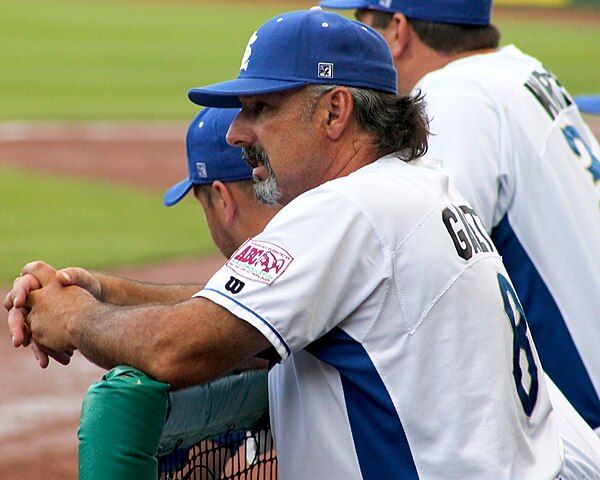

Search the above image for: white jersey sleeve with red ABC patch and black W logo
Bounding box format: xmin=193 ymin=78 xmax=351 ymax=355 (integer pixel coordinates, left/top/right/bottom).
xmin=196 ymin=188 xmax=386 ymax=360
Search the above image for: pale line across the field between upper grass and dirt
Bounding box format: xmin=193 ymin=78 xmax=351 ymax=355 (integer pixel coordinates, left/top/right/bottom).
xmin=0 ymin=121 xmax=187 ymax=142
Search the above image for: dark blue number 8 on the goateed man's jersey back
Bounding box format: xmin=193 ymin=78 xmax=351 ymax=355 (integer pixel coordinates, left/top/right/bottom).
xmin=498 ymin=273 xmax=538 ymax=417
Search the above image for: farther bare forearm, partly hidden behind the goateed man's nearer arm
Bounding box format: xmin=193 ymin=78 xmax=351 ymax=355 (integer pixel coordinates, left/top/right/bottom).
xmin=93 ymin=273 xmax=202 ymax=306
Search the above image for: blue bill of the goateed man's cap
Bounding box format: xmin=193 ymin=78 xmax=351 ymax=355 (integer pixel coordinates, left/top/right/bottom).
xmin=188 ymin=77 xmax=309 ymax=108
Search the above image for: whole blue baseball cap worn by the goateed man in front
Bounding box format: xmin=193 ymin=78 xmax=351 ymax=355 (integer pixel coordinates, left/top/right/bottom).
xmin=188 ymin=7 xmax=396 ymax=108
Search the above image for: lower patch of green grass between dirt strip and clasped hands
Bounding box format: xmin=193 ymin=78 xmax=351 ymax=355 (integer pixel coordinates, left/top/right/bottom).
xmin=0 ymin=165 xmax=216 ymax=285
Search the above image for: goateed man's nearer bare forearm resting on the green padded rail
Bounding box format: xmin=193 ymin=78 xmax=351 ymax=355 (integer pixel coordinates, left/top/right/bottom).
xmin=69 ymin=298 xmax=270 ymax=388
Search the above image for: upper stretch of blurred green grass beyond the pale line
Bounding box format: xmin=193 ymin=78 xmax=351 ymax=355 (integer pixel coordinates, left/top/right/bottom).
xmin=0 ymin=0 xmax=600 ymax=120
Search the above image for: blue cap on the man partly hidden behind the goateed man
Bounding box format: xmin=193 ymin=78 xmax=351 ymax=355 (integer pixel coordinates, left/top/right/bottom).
xmin=163 ymin=108 xmax=252 ymax=207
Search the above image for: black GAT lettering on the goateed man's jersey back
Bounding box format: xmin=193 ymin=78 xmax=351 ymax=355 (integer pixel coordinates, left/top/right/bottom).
xmin=442 ymin=205 xmax=496 ymax=260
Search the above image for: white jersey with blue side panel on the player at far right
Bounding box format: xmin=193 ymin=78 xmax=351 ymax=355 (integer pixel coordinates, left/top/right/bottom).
xmin=416 ymin=46 xmax=600 ymax=431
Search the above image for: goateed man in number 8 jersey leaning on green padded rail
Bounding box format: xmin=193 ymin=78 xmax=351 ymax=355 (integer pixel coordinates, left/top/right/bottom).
xmin=9 ymin=10 xmax=563 ymax=480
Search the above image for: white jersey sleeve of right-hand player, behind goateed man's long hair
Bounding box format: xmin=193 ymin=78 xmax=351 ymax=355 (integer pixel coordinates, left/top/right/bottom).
xmin=420 ymin=77 xmax=506 ymax=232
